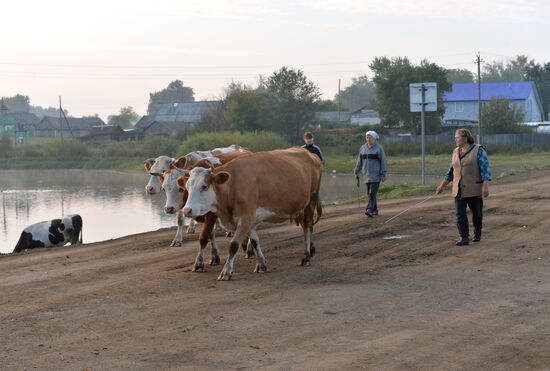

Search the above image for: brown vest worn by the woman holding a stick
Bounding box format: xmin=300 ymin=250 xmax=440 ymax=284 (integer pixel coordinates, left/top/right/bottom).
xmin=452 ymin=144 xmax=483 ymax=197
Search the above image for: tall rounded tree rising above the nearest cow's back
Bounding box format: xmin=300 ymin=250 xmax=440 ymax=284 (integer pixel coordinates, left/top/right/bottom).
xmin=265 ymin=67 xmax=321 ymax=143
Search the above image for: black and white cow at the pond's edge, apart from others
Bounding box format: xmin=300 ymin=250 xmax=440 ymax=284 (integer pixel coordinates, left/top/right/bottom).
xmin=13 ymin=214 xmax=82 ymax=252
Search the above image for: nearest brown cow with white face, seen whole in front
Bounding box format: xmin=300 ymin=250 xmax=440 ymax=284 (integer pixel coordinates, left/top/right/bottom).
xmin=178 ymin=147 xmax=323 ymax=280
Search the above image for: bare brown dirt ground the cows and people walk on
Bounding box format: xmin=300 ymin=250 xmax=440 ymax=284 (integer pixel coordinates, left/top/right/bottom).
xmin=0 ymin=171 xmax=550 ymax=370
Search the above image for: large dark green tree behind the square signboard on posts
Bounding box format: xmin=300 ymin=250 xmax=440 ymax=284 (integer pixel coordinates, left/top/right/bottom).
xmin=369 ymin=57 xmax=451 ymax=134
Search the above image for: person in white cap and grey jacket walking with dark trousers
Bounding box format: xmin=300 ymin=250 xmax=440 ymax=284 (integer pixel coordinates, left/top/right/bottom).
xmin=354 ymin=130 xmax=388 ymax=217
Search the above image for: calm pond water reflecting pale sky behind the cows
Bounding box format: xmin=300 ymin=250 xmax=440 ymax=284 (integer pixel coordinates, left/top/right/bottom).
xmin=0 ymin=170 xmax=439 ymax=252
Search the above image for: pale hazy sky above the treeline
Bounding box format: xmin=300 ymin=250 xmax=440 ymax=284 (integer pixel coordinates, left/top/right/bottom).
xmin=0 ymin=0 xmax=550 ymax=121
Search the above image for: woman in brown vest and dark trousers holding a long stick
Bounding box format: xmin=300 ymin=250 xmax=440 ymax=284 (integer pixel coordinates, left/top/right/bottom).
xmin=436 ymin=129 xmax=492 ymax=246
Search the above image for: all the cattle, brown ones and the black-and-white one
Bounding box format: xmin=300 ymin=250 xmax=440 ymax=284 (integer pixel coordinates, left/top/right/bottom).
xmin=14 ymin=145 xmax=322 ymax=280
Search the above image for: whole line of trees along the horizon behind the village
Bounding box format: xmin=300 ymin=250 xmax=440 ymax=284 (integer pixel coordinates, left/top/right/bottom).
xmin=4 ymin=56 xmax=550 ymax=138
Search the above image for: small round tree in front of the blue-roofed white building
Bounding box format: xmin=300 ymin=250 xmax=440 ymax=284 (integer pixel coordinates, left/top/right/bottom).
xmin=481 ymin=99 xmax=530 ymax=134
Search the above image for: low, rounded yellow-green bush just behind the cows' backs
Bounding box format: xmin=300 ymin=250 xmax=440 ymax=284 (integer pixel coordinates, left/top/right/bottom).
xmin=177 ymin=131 xmax=290 ymax=156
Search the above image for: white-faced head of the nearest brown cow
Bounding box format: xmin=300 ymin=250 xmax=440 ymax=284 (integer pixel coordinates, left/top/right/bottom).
xmin=178 ymin=167 xmax=230 ymax=218
